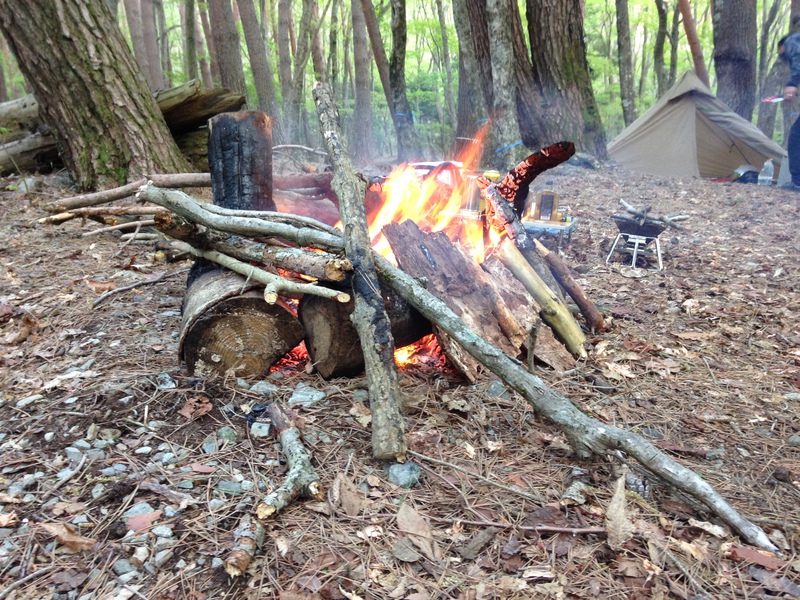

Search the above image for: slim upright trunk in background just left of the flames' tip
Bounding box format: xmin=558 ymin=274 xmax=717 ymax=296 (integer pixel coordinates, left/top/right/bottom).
xmin=389 ymin=0 xmax=421 ymax=162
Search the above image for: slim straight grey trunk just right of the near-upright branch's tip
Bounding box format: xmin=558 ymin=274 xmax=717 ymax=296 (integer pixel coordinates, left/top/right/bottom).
xmin=351 ymin=0 xmax=373 ymax=164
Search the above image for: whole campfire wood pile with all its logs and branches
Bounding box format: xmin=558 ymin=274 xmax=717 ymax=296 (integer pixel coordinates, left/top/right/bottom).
xmin=34 ymin=85 xmax=775 ymax=556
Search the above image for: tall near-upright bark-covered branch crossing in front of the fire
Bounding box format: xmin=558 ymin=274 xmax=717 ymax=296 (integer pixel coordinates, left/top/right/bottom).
xmin=313 ymin=82 xmax=406 ymax=462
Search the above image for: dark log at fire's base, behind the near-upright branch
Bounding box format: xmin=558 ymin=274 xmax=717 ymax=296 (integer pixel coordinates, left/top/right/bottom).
xmin=297 ymin=285 xmax=431 ymax=379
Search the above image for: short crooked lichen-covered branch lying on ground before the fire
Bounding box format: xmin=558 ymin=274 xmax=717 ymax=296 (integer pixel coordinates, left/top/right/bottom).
xmin=256 ymin=402 xmax=323 ymax=519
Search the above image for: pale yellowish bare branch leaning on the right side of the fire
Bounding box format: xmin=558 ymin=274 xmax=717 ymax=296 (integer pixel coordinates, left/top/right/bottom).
xmin=494 ymin=237 xmax=586 ymax=358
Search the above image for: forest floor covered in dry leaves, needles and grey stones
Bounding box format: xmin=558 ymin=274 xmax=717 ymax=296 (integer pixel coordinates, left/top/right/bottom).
xmin=0 ymin=161 xmax=800 ymax=600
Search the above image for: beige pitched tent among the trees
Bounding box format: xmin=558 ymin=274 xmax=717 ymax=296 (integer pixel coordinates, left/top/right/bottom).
xmin=608 ymin=71 xmax=786 ymax=177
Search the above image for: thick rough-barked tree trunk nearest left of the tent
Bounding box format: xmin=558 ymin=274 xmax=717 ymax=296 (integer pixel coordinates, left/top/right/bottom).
xmin=527 ymin=0 xmax=606 ymax=158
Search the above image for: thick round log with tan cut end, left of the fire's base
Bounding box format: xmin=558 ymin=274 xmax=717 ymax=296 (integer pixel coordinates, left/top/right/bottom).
xmin=178 ymin=266 xmax=303 ymax=378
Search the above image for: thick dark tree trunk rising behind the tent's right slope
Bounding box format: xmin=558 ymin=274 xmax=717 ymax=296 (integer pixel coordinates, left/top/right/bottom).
xmin=713 ymin=0 xmax=758 ymax=121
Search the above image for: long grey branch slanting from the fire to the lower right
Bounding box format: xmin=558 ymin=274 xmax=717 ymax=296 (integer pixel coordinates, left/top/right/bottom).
xmin=373 ymin=253 xmax=778 ymax=552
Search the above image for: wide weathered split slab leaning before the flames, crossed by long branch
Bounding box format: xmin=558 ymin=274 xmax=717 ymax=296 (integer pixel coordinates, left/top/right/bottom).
xmin=383 ymin=221 xmax=519 ymax=381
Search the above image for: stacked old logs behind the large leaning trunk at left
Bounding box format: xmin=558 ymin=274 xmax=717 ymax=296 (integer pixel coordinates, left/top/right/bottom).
xmin=0 ymin=79 xmax=245 ymax=174
